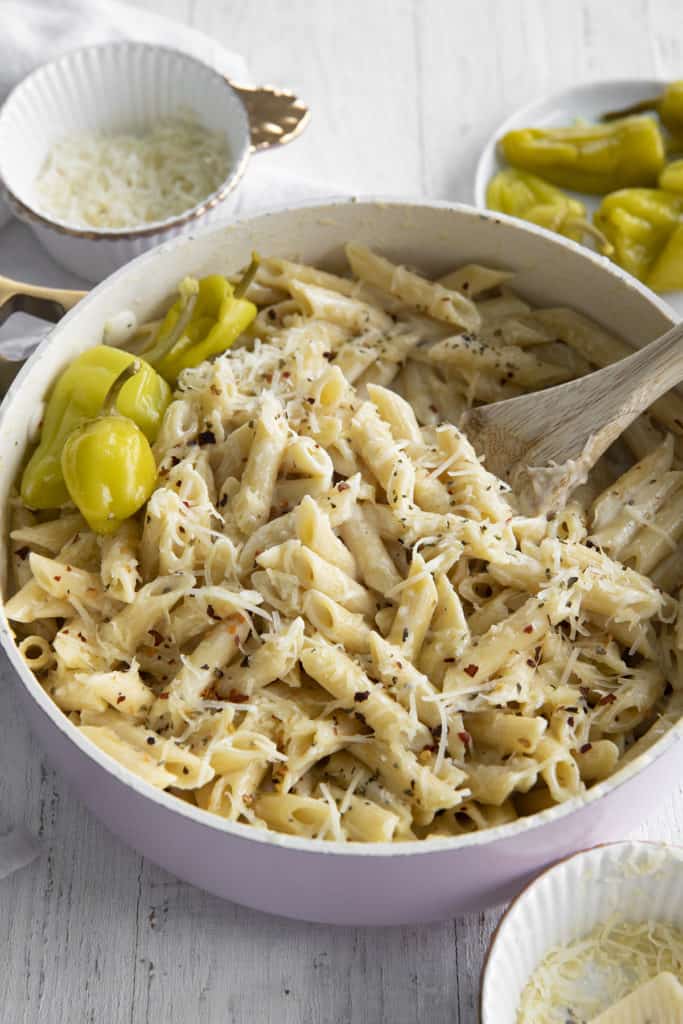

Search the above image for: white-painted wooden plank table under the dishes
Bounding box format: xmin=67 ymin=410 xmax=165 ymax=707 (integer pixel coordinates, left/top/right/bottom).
xmin=0 ymin=0 xmax=683 ymax=1024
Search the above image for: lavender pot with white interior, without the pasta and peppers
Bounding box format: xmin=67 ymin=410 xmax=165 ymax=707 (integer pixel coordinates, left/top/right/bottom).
xmin=0 ymin=201 xmax=682 ymax=925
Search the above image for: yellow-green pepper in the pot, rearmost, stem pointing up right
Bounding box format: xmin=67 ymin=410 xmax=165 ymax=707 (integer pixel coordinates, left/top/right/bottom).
xmin=142 ymin=254 xmax=259 ymax=384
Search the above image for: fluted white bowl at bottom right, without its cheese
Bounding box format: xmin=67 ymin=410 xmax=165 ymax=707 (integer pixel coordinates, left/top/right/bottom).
xmin=480 ymin=841 xmax=683 ymax=1024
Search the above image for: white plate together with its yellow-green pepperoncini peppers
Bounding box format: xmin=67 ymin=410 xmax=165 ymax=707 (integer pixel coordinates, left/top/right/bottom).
xmin=474 ymin=79 xmax=683 ymax=315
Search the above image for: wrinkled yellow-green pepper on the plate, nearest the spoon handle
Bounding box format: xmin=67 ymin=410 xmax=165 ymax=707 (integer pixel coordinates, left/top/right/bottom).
xmin=594 ymin=188 xmax=683 ymax=291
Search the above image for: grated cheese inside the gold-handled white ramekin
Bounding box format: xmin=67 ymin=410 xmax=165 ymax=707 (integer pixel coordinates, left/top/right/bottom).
xmin=35 ymin=112 xmax=231 ymax=229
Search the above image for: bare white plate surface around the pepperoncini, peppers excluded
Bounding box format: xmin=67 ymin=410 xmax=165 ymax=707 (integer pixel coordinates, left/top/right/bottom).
xmin=474 ymin=78 xmax=683 ymax=316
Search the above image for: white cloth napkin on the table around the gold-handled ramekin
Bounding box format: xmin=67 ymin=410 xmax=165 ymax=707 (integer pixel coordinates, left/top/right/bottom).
xmin=0 ymin=0 xmax=342 ymax=880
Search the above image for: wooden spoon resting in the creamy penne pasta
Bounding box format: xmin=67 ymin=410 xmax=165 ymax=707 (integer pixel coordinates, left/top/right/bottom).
xmin=463 ymin=324 xmax=683 ymax=514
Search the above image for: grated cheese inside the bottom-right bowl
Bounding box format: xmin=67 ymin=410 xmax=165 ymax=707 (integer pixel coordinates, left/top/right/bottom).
xmin=517 ymin=916 xmax=683 ymax=1024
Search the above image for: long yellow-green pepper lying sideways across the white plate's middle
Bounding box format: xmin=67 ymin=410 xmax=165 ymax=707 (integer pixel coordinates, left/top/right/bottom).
xmin=499 ymin=117 xmax=665 ymax=196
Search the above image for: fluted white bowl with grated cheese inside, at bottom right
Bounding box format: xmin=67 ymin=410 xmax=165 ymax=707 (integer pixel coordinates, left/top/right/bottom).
xmin=481 ymin=841 xmax=683 ymax=1024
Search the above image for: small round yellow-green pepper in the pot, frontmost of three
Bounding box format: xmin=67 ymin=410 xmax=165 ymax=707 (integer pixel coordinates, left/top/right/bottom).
xmin=61 ymin=360 xmax=157 ymax=534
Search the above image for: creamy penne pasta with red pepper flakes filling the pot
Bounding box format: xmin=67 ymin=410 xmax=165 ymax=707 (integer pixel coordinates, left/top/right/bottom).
xmin=5 ymin=245 xmax=683 ymax=843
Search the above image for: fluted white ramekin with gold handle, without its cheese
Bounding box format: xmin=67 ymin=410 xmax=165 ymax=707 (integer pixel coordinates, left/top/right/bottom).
xmin=0 ymin=42 xmax=308 ymax=282
